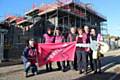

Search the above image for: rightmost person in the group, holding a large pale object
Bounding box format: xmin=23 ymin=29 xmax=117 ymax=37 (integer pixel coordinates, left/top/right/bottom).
xmin=90 ymin=29 xmax=103 ymax=74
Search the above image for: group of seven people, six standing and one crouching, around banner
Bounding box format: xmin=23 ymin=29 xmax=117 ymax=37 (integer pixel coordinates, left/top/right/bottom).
xmin=23 ymin=26 xmax=102 ymax=76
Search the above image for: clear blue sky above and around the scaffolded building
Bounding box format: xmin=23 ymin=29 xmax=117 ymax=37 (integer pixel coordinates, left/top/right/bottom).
xmin=0 ymin=0 xmax=120 ymax=35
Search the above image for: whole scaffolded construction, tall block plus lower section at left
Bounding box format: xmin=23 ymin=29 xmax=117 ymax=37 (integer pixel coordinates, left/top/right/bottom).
xmin=0 ymin=0 xmax=106 ymax=61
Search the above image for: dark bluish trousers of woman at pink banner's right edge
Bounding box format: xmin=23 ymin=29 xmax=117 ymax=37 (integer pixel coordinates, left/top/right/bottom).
xmin=76 ymin=50 xmax=87 ymax=71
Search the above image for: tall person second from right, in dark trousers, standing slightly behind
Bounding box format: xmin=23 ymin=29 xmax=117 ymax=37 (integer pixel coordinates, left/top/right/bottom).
xmin=84 ymin=25 xmax=94 ymax=71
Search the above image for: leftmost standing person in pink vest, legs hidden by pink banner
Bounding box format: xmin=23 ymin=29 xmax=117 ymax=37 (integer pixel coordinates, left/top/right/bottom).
xmin=43 ymin=27 xmax=54 ymax=71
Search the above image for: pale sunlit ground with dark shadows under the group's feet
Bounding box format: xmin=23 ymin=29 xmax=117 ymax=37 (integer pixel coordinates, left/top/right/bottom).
xmin=0 ymin=49 xmax=120 ymax=80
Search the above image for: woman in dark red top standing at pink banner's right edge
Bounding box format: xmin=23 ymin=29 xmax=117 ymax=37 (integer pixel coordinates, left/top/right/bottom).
xmin=76 ymin=28 xmax=87 ymax=74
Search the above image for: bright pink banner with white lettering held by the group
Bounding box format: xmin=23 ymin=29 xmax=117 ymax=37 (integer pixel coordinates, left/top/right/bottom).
xmin=37 ymin=42 xmax=76 ymax=66
